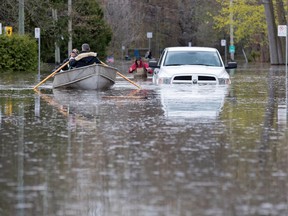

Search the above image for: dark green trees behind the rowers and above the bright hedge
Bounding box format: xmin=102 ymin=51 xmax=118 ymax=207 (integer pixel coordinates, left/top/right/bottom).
xmin=0 ymin=0 xmax=112 ymax=63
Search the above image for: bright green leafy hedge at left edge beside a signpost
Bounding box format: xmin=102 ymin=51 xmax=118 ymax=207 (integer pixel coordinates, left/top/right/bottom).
xmin=0 ymin=34 xmax=37 ymax=72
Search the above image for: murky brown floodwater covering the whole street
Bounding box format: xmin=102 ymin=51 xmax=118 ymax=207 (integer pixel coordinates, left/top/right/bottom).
xmin=0 ymin=62 xmax=288 ymax=216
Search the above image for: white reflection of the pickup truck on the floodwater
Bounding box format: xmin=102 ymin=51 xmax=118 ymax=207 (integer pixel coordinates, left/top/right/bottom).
xmin=159 ymin=85 xmax=228 ymax=120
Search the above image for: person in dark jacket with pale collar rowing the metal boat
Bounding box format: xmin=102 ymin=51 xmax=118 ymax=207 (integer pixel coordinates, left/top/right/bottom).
xmin=69 ymin=43 xmax=101 ymax=68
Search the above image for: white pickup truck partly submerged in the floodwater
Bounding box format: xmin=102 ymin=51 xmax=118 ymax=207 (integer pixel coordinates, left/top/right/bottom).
xmin=149 ymin=47 xmax=237 ymax=84
